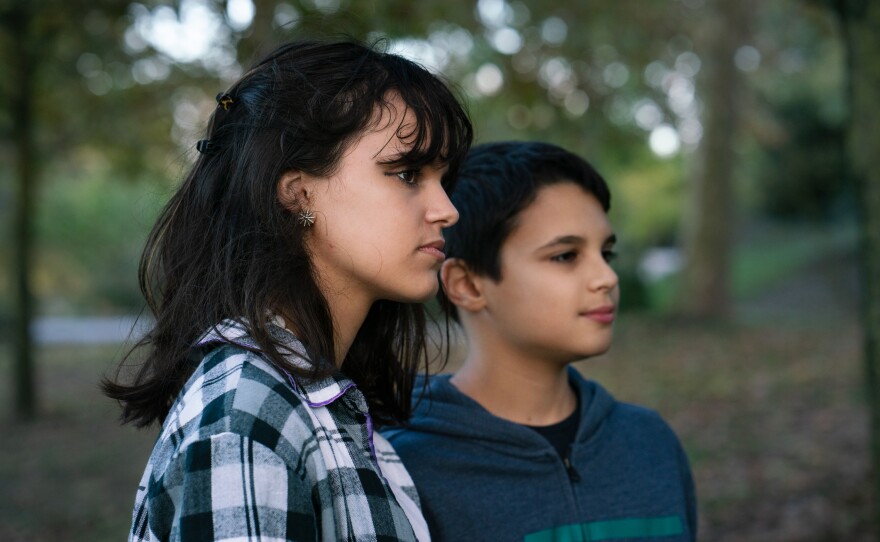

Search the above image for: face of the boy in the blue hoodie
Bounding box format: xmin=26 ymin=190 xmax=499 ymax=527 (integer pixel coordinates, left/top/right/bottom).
xmin=481 ymin=182 xmax=619 ymax=363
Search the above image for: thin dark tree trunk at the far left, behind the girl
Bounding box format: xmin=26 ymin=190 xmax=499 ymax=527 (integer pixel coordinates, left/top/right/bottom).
xmin=10 ymin=2 xmax=37 ymax=419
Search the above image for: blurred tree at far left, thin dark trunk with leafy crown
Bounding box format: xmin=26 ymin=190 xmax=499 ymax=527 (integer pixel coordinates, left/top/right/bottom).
xmin=0 ymin=0 xmax=192 ymax=419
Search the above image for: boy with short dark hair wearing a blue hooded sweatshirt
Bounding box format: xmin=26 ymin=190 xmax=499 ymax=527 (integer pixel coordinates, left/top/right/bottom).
xmin=387 ymin=142 xmax=696 ymax=542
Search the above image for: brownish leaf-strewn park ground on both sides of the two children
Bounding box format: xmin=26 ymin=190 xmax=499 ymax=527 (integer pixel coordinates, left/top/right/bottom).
xmin=0 ymin=253 xmax=877 ymax=542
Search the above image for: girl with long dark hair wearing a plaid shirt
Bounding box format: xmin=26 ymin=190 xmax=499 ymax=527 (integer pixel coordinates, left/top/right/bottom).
xmin=103 ymin=41 xmax=472 ymax=540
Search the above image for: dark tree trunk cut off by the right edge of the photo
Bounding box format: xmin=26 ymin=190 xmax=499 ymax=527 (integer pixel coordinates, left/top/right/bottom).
xmin=838 ymin=0 xmax=880 ymax=521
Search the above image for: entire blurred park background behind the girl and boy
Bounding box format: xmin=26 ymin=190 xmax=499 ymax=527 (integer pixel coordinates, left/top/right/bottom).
xmin=0 ymin=0 xmax=880 ymax=541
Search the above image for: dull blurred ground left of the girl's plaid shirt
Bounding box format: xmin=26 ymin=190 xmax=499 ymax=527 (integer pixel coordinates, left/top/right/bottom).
xmin=0 ymin=347 xmax=154 ymax=542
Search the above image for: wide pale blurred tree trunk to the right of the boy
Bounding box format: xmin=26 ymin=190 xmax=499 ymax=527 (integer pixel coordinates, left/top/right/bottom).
xmin=679 ymin=0 xmax=747 ymax=318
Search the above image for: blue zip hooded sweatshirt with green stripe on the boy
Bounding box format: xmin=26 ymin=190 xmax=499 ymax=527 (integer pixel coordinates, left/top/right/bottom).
xmin=384 ymin=368 xmax=697 ymax=542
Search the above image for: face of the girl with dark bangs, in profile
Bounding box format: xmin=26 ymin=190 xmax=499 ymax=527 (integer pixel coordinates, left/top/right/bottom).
xmin=302 ymin=95 xmax=458 ymax=312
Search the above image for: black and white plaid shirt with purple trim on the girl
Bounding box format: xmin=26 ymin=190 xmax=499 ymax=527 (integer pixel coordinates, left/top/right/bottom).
xmin=129 ymin=321 xmax=428 ymax=542
